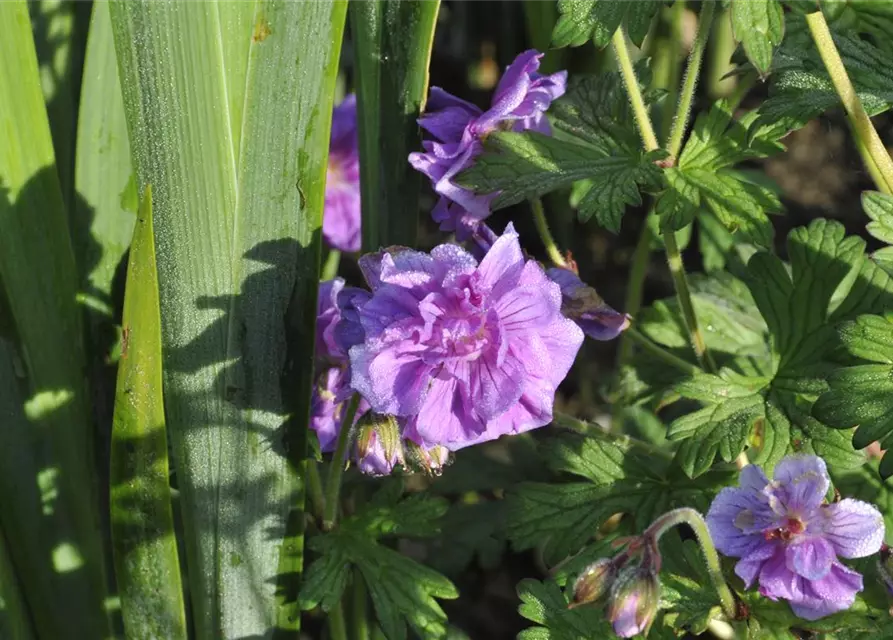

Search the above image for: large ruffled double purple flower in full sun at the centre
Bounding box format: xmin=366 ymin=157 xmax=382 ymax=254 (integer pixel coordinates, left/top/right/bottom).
xmin=350 ymin=225 xmax=583 ymax=450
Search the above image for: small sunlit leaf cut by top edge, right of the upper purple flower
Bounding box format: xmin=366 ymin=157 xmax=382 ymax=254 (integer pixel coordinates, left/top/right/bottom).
xmin=552 ymin=0 xmax=670 ymax=49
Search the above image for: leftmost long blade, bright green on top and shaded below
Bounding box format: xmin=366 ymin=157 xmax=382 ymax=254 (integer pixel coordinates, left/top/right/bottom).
xmin=0 ymin=0 xmax=108 ymax=638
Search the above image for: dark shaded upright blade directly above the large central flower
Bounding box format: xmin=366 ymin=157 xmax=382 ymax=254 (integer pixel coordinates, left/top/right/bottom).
xmin=350 ymin=0 xmax=440 ymax=251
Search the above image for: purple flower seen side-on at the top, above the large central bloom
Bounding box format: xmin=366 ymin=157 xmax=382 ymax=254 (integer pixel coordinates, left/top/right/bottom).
xmin=409 ymin=49 xmax=567 ymax=240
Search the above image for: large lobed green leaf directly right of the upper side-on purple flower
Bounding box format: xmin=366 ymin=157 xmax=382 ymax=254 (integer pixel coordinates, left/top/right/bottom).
xmin=459 ymin=67 xmax=666 ymax=232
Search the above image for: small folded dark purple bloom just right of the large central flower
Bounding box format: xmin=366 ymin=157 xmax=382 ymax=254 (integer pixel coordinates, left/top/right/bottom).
xmin=546 ymin=268 xmax=631 ymax=340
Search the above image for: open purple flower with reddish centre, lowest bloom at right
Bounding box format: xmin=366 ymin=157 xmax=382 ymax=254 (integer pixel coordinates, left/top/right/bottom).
xmin=707 ymin=456 xmax=884 ymax=620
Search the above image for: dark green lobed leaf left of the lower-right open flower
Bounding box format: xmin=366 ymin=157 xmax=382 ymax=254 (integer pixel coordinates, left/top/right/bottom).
xmin=506 ymin=426 xmax=730 ymax=563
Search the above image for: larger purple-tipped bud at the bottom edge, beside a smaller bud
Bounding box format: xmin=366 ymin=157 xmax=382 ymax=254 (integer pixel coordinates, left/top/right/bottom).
xmin=607 ymin=563 xmax=660 ymax=638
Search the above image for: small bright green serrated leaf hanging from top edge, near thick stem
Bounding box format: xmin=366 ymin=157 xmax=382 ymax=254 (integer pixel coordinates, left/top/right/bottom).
xmin=732 ymin=0 xmax=784 ymax=76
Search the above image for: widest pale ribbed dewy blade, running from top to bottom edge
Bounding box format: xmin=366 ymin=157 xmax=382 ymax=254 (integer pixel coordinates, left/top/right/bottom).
xmin=110 ymin=0 xmax=346 ymax=639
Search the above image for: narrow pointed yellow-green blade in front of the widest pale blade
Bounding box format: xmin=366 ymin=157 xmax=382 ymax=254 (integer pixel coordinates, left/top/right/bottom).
xmin=110 ymin=188 xmax=187 ymax=640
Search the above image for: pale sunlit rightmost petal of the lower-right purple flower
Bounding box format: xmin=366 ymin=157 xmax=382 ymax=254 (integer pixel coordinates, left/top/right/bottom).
xmin=822 ymin=498 xmax=884 ymax=558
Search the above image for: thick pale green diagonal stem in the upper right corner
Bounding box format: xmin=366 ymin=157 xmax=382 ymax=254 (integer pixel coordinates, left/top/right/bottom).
xmin=806 ymin=11 xmax=893 ymax=193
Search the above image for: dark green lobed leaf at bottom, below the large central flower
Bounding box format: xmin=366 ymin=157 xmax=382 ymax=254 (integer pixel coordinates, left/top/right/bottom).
xmin=298 ymin=481 xmax=459 ymax=640
